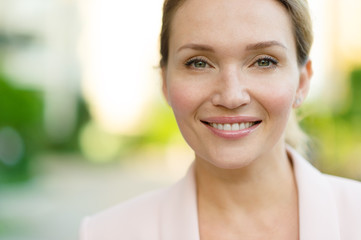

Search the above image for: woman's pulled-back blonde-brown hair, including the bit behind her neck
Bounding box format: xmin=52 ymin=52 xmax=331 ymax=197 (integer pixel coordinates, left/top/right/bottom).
xmin=160 ymin=0 xmax=313 ymax=154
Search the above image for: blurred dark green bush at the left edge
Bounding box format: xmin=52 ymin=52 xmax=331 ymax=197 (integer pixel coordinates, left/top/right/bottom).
xmin=0 ymin=76 xmax=44 ymax=183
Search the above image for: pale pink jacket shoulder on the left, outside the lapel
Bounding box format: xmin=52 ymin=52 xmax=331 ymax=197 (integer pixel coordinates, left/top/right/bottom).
xmin=80 ymin=189 xmax=169 ymax=240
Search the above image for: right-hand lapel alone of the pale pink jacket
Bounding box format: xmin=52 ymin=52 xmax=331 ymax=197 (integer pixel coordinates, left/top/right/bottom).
xmin=288 ymin=148 xmax=340 ymax=240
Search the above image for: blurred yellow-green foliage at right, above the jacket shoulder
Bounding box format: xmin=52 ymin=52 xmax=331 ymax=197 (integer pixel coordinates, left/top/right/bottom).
xmin=301 ymin=69 xmax=361 ymax=180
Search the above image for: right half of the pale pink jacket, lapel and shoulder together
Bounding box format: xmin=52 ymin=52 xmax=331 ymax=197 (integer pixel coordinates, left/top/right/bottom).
xmin=288 ymin=148 xmax=361 ymax=240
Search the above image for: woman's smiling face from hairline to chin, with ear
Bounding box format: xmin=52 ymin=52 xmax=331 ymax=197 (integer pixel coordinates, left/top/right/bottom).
xmin=163 ymin=0 xmax=311 ymax=168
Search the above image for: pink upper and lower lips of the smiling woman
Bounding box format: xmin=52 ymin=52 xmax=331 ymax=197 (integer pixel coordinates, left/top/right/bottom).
xmin=201 ymin=116 xmax=262 ymax=139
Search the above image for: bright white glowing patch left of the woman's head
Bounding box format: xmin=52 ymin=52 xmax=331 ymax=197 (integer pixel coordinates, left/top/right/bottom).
xmin=79 ymin=0 xmax=162 ymax=134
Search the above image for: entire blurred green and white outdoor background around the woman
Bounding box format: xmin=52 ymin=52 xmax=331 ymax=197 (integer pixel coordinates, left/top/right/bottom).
xmin=0 ymin=0 xmax=361 ymax=240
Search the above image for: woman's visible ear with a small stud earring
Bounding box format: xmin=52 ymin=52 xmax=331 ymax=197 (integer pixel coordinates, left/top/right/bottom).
xmin=293 ymin=60 xmax=313 ymax=108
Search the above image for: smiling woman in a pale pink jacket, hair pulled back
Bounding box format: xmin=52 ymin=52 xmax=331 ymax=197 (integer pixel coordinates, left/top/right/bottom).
xmin=81 ymin=0 xmax=361 ymax=240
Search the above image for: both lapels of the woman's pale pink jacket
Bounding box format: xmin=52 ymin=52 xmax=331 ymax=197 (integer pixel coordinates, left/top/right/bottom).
xmin=160 ymin=147 xmax=340 ymax=240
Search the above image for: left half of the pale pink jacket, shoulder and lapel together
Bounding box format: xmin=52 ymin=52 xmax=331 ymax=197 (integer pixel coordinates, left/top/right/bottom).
xmin=80 ymin=165 xmax=197 ymax=240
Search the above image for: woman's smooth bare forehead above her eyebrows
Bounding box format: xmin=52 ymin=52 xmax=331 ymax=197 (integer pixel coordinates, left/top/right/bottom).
xmin=170 ymin=0 xmax=295 ymax=52
